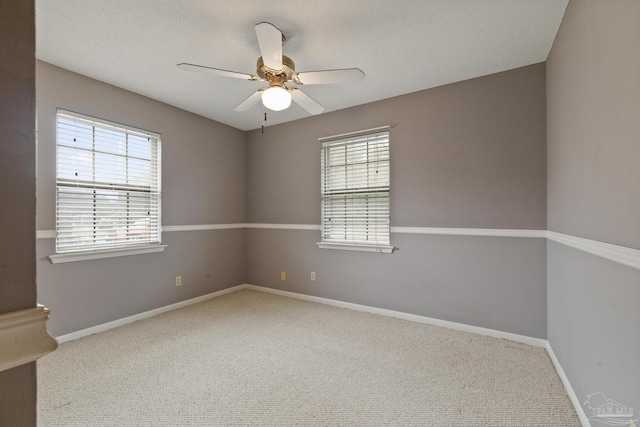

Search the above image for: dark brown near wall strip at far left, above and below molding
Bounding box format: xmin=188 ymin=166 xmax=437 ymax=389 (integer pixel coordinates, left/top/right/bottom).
xmin=0 ymin=0 xmax=36 ymax=427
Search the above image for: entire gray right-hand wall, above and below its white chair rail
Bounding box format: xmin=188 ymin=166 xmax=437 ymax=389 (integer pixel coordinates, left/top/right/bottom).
xmin=547 ymin=0 xmax=640 ymax=413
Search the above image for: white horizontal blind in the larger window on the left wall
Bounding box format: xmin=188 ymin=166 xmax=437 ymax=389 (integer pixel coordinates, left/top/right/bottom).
xmin=56 ymin=110 xmax=161 ymax=253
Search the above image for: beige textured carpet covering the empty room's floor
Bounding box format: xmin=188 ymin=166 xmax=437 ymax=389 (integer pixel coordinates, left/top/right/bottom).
xmin=38 ymin=290 xmax=580 ymax=427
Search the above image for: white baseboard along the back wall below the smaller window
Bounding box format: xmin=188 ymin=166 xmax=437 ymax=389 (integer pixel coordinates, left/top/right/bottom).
xmin=241 ymin=285 xmax=547 ymax=348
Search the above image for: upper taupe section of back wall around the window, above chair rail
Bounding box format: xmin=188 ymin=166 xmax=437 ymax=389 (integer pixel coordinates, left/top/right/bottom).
xmin=247 ymin=64 xmax=546 ymax=229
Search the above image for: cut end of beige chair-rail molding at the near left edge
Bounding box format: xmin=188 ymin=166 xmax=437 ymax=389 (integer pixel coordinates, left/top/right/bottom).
xmin=0 ymin=306 xmax=58 ymax=371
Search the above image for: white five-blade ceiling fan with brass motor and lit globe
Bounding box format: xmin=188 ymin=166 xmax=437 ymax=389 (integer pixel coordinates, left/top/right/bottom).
xmin=178 ymin=22 xmax=364 ymax=114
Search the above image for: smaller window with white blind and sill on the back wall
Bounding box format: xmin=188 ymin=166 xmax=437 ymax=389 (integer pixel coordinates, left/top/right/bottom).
xmin=318 ymin=127 xmax=393 ymax=253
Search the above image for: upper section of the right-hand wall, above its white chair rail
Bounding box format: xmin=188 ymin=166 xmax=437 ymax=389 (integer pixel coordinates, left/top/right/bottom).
xmin=547 ymin=0 xmax=640 ymax=249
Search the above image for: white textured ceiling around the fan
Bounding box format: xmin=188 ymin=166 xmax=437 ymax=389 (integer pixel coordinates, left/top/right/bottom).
xmin=36 ymin=0 xmax=568 ymax=130
